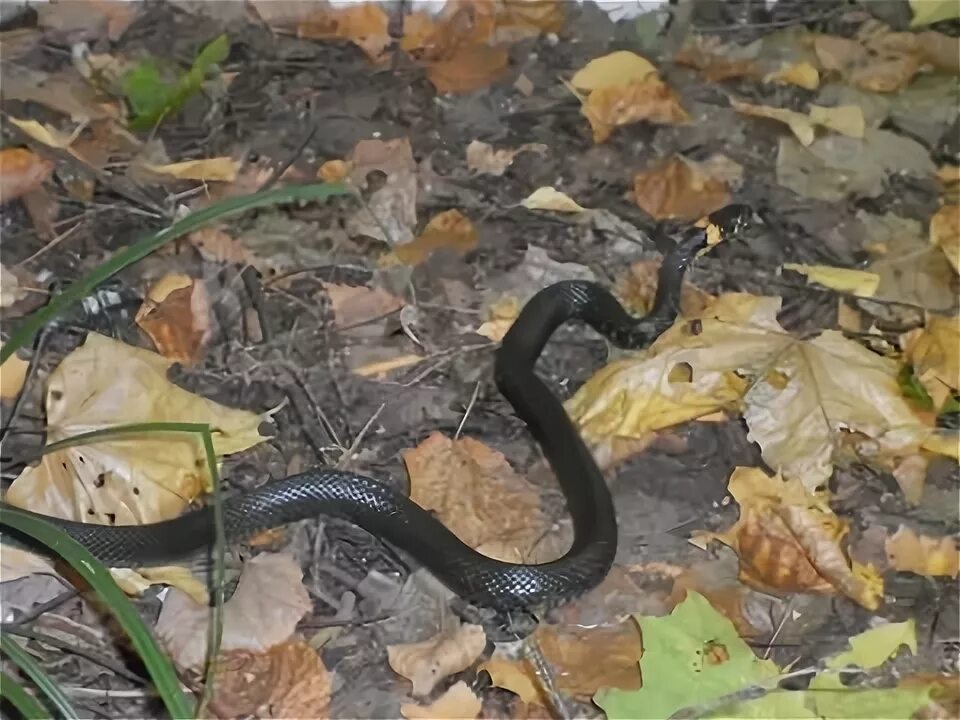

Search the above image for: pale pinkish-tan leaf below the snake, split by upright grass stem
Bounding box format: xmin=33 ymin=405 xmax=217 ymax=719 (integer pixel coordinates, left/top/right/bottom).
xmin=154 ymin=553 xmax=313 ymax=670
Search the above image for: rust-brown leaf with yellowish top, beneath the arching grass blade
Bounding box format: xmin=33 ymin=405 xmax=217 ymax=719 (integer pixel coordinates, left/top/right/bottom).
xmin=134 ymin=273 xmax=211 ymax=365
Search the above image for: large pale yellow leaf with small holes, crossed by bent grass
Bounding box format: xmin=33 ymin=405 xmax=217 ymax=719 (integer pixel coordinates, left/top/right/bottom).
xmin=5 ymin=333 xmax=267 ymax=525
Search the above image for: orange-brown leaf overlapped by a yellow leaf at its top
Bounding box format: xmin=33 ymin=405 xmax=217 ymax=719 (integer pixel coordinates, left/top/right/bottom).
xmin=580 ymin=75 xmax=690 ymax=143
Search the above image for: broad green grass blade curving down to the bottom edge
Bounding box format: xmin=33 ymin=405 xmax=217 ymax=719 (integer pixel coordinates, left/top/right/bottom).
xmin=0 ymin=505 xmax=193 ymax=719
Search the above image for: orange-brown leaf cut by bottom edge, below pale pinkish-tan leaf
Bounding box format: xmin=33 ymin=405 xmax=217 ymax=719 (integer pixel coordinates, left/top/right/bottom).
xmin=210 ymin=641 xmax=332 ymax=718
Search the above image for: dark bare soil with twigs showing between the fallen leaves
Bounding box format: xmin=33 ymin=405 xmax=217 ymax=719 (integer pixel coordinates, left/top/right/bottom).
xmin=2 ymin=0 xmax=960 ymax=718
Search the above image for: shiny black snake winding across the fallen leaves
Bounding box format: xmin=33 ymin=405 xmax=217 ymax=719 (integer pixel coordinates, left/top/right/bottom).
xmin=0 ymin=206 xmax=746 ymax=612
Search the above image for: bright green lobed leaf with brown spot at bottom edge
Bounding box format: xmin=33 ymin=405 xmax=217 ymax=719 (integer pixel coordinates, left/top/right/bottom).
xmin=594 ymin=592 xmax=780 ymax=720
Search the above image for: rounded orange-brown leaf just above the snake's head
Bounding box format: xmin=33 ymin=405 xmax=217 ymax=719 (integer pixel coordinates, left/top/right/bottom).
xmin=633 ymin=156 xmax=730 ymax=220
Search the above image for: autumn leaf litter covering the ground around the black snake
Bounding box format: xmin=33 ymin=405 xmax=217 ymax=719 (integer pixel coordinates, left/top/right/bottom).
xmin=0 ymin=0 xmax=960 ymax=718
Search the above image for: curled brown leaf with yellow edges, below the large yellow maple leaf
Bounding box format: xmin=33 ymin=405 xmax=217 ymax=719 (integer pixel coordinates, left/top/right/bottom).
xmin=699 ymin=467 xmax=883 ymax=610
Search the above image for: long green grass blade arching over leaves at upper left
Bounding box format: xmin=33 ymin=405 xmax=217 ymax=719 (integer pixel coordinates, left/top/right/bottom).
xmin=0 ymin=183 xmax=353 ymax=365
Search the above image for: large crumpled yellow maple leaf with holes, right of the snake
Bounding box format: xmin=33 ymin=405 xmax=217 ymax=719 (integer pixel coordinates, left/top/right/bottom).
xmin=567 ymin=293 xmax=932 ymax=488
